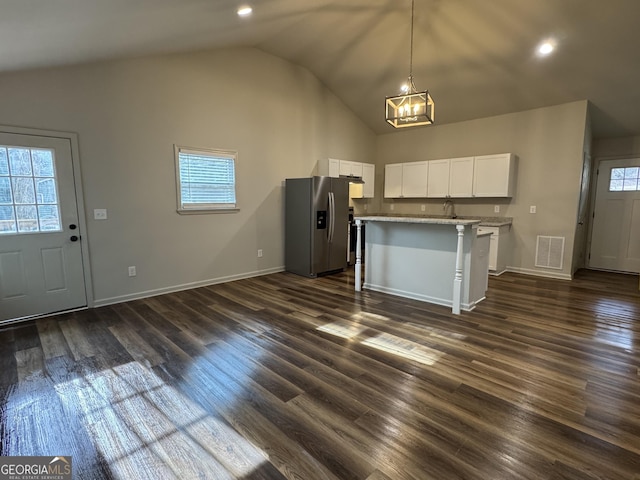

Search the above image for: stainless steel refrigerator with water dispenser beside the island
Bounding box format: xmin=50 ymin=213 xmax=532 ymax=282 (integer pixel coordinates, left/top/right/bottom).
xmin=284 ymin=177 xmax=349 ymax=277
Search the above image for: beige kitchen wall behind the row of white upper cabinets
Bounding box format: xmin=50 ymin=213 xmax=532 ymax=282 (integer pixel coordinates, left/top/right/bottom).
xmin=375 ymin=101 xmax=587 ymax=278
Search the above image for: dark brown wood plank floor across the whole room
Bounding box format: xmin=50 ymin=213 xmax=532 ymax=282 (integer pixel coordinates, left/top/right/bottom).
xmin=0 ymin=271 xmax=640 ymax=480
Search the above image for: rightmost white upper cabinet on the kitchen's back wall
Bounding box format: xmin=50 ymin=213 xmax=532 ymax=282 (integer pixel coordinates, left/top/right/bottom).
xmin=473 ymin=153 xmax=517 ymax=197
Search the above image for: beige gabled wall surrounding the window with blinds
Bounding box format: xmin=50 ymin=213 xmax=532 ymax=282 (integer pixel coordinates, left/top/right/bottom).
xmin=0 ymin=49 xmax=375 ymax=304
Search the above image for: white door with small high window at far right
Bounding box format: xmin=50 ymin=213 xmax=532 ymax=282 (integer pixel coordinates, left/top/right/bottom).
xmin=589 ymin=158 xmax=640 ymax=273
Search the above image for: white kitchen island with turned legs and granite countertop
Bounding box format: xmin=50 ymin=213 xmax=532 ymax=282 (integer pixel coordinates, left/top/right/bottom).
xmin=355 ymin=215 xmax=490 ymax=314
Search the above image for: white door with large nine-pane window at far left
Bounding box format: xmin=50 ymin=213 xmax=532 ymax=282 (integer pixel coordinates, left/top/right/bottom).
xmin=0 ymin=133 xmax=87 ymax=323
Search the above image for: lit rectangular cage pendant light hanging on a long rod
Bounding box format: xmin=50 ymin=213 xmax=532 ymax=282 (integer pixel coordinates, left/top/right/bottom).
xmin=385 ymin=0 xmax=435 ymax=128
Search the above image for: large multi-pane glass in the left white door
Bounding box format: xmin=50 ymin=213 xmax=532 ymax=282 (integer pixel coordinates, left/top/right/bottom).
xmin=0 ymin=145 xmax=62 ymax=235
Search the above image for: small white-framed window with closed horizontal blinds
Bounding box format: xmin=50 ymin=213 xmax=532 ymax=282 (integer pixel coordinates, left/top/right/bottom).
xmin=175 ymin=146 xmax=237 ymax=213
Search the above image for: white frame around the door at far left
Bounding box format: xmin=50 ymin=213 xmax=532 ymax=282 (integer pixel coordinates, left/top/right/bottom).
xmin=0 ymin=125 xmax=94 ymax=316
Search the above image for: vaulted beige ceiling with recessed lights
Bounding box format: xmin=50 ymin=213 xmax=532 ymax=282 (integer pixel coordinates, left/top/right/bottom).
xmin=0 ymin=0 xmax=640 ymax=137
